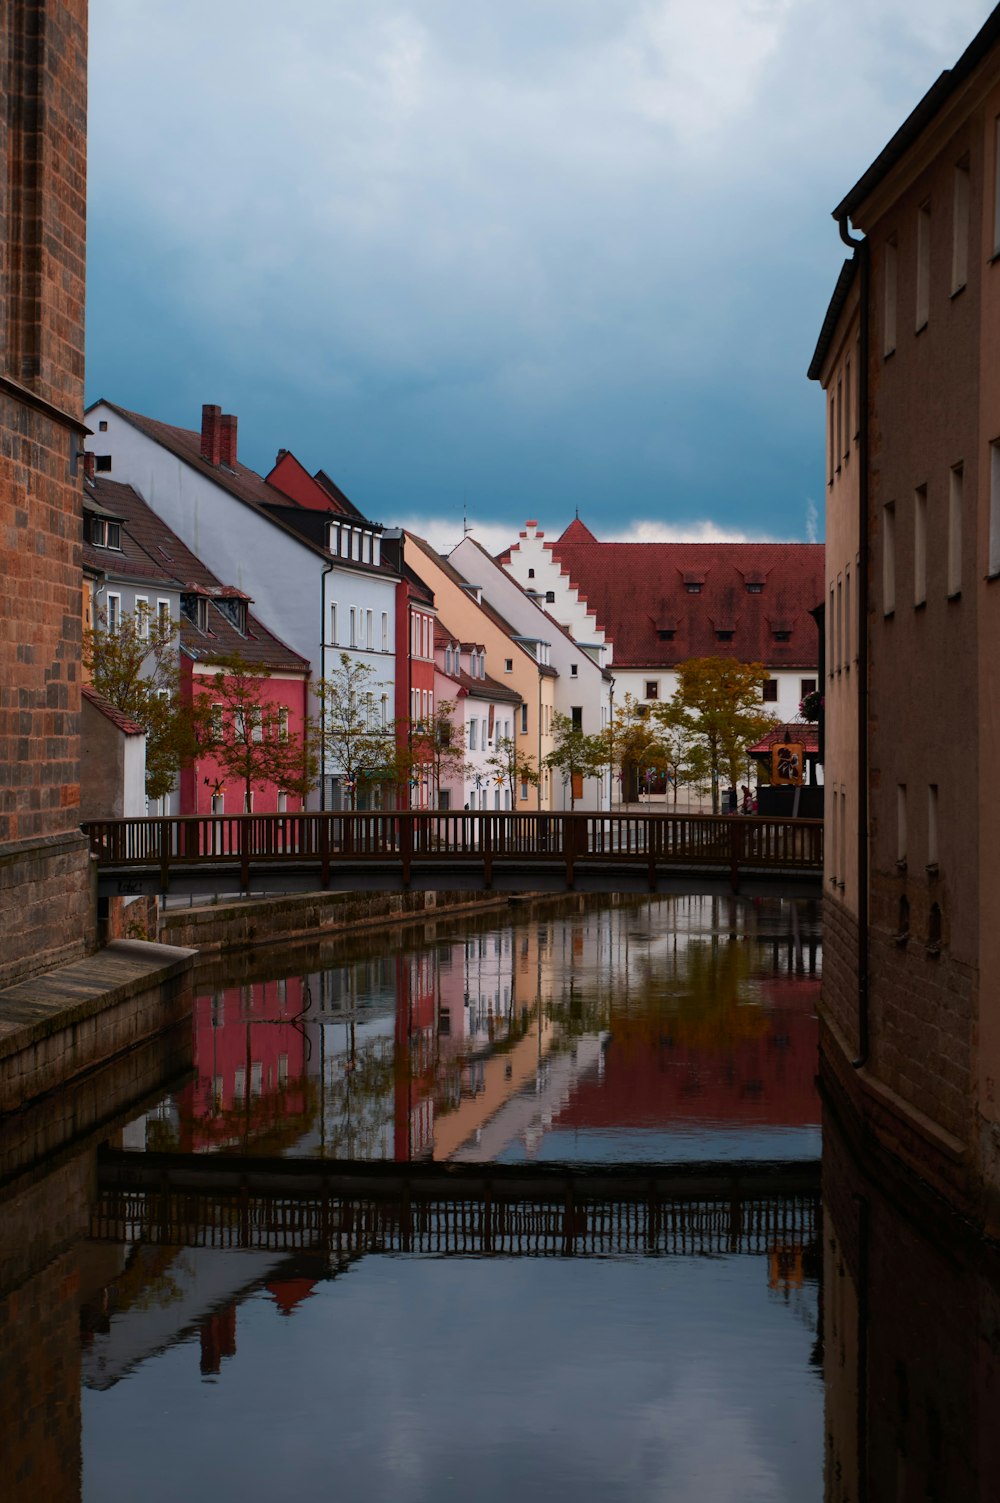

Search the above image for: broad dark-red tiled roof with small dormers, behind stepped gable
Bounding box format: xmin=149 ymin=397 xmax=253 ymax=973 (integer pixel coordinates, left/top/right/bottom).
xmin=549 ymin=525 xmax=824 ymax=667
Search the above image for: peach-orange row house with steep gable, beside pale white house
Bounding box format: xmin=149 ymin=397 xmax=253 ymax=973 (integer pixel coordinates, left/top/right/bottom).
xmin=405 ymin=532 xmax=558 ymax=810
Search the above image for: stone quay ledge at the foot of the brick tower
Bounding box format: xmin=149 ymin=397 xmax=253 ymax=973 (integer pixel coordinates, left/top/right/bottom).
xmin=0 ymin=939 xmax=194 ymax=1114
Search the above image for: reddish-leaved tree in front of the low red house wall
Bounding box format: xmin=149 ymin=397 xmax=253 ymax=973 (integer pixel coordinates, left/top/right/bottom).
xmin=197 ymin=652 xmax=319 ymax=810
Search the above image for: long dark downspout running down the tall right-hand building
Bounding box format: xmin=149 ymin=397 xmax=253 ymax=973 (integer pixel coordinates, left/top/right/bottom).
xmin=838 ymin=215 xmax=871 ymax=1070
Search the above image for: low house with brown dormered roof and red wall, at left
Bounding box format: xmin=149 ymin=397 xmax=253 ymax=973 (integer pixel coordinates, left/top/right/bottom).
xmin=83 ymin=474 xmax=310 ymax=815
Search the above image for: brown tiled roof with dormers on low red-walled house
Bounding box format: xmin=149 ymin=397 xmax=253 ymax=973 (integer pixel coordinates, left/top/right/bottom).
xmin=84 ymin=481 xmax=310 ymax=673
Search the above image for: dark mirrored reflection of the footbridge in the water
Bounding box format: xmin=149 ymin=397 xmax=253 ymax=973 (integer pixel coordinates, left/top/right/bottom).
xmin=90 ymin=1150 xmax=820 ymax=1261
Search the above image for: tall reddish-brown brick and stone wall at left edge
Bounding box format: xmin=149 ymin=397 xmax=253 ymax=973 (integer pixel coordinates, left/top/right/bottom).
xmin=0 ymin=0 xmax=93 ymax=984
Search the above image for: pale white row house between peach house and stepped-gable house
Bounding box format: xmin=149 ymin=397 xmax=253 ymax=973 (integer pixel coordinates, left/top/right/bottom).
xmin=448 ymin=537 xmax=614 ymax=810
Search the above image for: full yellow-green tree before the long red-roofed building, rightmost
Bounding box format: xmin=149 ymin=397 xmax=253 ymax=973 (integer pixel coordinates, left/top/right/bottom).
xmin=674 ymin=657 xmax=777 ymax=813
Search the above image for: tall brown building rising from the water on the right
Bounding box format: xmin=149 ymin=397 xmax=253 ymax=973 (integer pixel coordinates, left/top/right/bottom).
xmin=809 ymin=8 xmax=1000 ymax=1234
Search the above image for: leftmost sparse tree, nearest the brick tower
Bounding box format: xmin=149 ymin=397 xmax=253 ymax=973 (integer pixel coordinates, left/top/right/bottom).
xmin=83 ymin=609 xmax=205 ymax=798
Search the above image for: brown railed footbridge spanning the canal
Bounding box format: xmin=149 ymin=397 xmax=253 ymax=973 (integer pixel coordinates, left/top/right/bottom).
xmin=83 ymin=810 xmax=823 ymax=899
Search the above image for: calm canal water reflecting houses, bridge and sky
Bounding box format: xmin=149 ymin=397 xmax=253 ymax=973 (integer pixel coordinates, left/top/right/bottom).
xmin=0 ymin=897 xmax=1000 ymax=1503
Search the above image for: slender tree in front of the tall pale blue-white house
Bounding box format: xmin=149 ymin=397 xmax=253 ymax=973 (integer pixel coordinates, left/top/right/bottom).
xmin=317 ymin=652 xmax=396 ymax=807
